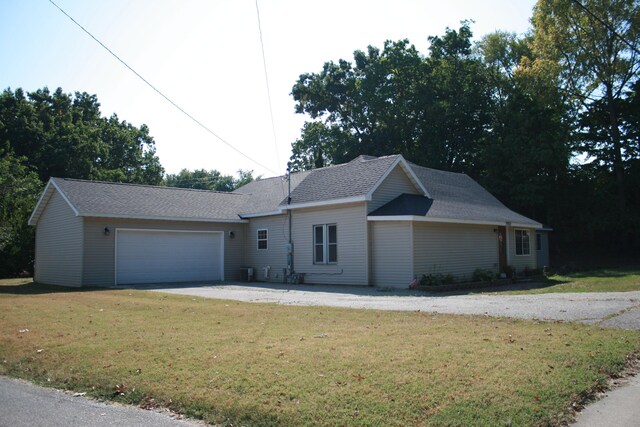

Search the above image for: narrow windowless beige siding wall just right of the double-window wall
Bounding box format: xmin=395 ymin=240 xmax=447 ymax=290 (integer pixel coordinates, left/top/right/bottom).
xmin=370 ymin=221 xmax=413 ymax=288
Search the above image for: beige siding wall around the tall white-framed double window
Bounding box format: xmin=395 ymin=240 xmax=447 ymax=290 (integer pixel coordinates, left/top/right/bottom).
xmin=292 ymin=203 xmax=368 ymax=285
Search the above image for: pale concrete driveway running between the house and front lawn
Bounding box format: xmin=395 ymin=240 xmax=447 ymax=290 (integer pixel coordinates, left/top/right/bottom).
xmin=144 ymin=283 xmax=640 ymax=329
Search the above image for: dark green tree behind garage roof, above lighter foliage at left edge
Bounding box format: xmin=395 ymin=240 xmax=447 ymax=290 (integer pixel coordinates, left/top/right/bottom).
xmin=0 ymin=88 xmax=164 ymax=184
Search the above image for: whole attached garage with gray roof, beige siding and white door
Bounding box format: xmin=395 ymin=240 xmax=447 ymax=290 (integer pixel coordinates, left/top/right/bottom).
xmin=29 ymin=178 xmax=249 ymax=286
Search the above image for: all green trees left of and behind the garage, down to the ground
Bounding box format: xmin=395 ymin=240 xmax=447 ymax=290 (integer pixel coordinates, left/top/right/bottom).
xmin=0 ymin=88 xmax=164 ymax=276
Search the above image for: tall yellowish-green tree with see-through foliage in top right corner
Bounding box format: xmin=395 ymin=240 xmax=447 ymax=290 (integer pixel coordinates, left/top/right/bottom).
xmin=532 ymin=0 xmax=640 ymax=213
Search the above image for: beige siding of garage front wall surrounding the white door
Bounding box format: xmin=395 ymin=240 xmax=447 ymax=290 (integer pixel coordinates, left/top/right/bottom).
xmin=83 ymin=218 xmax=247 ymax=286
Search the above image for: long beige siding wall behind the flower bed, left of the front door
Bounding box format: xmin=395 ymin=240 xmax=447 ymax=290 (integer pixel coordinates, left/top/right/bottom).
xmin=413 ymin=222 xmax=498 ymax=280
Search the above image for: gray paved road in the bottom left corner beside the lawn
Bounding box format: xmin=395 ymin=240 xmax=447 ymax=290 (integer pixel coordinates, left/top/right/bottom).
xmin=0 ymin=377 xmax=203 ymax=427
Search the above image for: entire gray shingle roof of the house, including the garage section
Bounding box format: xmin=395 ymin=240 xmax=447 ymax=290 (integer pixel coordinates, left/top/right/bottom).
xmin=30 ymin=155 xmax=537 ymax=226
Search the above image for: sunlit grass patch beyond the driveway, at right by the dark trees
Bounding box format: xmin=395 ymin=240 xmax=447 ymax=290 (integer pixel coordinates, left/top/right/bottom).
xmin=489 ymin=267 xmax=640 ymax=295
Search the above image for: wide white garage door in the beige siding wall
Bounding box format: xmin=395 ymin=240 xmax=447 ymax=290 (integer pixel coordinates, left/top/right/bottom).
xmin=115 ymin=229 xmax=224 ymax=285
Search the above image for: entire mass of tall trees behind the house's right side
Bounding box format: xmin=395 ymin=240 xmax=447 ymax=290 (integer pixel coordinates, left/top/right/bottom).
xmin=291 ymin=4 xmax=640 ymax=259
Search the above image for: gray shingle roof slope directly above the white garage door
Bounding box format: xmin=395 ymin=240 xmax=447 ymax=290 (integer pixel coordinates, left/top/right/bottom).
xmin=52 ymin=178 xmax=249 ymax=221
